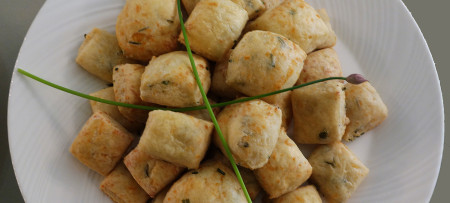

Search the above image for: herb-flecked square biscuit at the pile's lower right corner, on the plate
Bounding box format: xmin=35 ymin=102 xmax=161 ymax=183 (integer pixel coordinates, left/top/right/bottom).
xmin=308 ymin=142 xmax=369 ymax=202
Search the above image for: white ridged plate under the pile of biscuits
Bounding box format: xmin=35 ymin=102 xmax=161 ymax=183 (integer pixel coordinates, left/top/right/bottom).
xmin=8 ymin=0 xmax=444 ymax=203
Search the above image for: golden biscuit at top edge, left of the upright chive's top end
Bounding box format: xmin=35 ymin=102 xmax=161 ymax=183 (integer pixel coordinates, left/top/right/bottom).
xmin=116 ymin=0 xmax=180 ymax=61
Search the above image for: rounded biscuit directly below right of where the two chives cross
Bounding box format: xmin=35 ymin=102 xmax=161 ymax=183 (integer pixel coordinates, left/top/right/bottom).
xmin=214 ymin=100 xmax=281 ymax=170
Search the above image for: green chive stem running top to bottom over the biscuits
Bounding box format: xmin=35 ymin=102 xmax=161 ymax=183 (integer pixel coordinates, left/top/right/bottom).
xmin=177 ymin=0 xmax=252 ymax=203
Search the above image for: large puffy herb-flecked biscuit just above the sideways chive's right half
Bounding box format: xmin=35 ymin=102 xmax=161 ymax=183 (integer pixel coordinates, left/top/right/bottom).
xmin=225 ymin=31 xmax=306 ymax=118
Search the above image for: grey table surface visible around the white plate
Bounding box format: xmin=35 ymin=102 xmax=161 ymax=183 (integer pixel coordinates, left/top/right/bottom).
xmin=0 ymin=0 xmax=450 ymax=202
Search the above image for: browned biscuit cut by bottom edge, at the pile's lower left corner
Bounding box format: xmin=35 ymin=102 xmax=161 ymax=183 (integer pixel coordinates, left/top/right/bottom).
xmin=100 ymin=163 xmax=150 ymax=203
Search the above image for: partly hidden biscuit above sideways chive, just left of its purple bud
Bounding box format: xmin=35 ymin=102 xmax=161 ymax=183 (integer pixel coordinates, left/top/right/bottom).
xmin=296 ymin=48 xmax=342 ymax=85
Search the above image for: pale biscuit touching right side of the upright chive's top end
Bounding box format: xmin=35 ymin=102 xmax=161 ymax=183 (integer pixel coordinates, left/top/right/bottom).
xmin=178 ymin=0 xmax=248 ymax=61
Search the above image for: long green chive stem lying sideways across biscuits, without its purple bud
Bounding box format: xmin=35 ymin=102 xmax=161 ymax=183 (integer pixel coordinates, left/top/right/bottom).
xmin=17 ymin=68 xmax=346 ymax=112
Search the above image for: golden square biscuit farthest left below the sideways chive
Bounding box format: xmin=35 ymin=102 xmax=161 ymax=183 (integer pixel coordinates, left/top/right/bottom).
xmin=70 ymin=112 xmax=133 ymax=176
